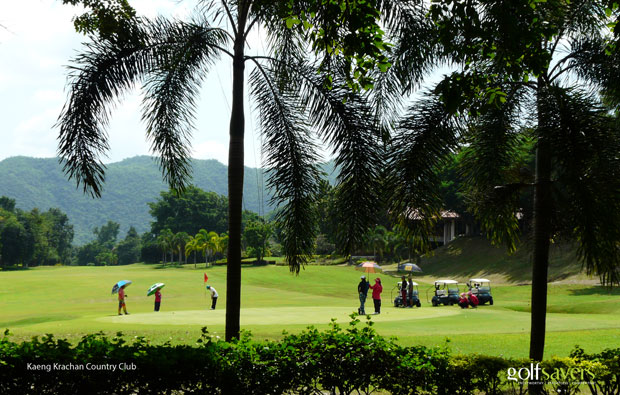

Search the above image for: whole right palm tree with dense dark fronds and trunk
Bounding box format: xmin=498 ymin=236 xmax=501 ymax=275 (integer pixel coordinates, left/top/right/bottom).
xmin=392 ymin=0 xmax=620 ymax=374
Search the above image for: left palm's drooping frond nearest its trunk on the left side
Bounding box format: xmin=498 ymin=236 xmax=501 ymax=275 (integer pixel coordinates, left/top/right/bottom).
xmin=142 ymin=19 xmax=227 ymax=190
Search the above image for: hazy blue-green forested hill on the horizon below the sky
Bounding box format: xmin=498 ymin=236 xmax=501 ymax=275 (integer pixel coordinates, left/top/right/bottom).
xmin=0 ymin=156 xmax=280 ymax=245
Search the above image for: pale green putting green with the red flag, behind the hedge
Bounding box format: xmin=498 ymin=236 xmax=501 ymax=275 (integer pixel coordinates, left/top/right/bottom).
xmin=96 ymin=306 xmax=459 ymax=330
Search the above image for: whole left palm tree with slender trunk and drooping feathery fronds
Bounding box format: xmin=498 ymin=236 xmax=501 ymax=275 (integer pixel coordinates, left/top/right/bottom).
xmin=58 ymin=0 xmax=422 ymax=340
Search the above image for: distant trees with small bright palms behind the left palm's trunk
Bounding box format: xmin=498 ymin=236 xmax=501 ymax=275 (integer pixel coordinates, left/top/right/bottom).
xmin=75 ymin=186 xmax=273 ymax=265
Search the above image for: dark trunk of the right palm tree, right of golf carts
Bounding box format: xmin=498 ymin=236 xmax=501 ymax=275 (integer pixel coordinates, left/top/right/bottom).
xmin=529 ymin=78 xmax=553 ymax=394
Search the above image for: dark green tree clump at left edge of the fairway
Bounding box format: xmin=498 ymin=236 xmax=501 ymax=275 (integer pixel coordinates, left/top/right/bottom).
xmin=0 ymin=196 xmax=73 ymax=266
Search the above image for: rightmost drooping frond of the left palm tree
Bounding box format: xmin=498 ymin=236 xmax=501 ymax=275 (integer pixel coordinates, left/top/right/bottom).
xmin=295 ymin=68 xmax=385 ymax=254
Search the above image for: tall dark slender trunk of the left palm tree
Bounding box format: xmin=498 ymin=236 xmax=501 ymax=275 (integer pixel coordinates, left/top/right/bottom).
xmin=226 ymin=17 xmax=247 ymax=341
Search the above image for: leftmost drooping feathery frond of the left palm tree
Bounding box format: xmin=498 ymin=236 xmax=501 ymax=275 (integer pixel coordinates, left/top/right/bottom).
xmin=56 ymin=22 xmax=152 ymax=196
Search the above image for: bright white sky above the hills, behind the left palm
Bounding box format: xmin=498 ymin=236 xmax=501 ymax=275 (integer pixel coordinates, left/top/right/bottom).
xmin=0 ymin=0 xmax=262 ymax=167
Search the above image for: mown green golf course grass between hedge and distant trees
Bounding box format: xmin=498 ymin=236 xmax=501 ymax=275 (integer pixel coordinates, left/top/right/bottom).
xmin=0 ymin=264 xmax=620 ymax=357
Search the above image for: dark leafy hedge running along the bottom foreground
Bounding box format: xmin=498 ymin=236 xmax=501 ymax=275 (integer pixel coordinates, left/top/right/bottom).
xmin=0 ymin=315 xmax=620 ymax=394
